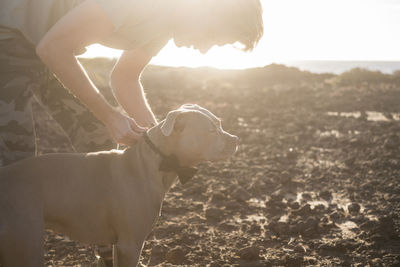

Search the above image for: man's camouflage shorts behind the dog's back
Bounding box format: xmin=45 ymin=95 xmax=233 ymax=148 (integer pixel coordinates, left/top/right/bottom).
xmin=0 ymin=26 xmax=115 ymax=166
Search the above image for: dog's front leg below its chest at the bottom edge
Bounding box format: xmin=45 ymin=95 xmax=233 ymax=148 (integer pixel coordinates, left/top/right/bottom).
xmin=114 ymin=241 xmax=144 ymax=267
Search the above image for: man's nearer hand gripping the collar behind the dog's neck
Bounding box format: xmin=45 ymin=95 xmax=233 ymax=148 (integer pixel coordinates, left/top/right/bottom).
xmin=105 ymin=111 xmax=146 ymax=146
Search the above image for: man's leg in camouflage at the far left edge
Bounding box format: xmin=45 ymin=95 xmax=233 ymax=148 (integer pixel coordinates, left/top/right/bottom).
xmin=0 ymin=27 xmax=40 ymax=166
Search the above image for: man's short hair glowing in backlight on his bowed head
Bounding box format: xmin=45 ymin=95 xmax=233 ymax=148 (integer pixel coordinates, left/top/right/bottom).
xmin=223 ymin=0 xmax=264 ymax=51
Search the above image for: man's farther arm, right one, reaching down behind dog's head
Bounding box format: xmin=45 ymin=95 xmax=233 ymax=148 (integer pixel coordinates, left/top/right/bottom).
xmin=111 ymin=49 xmax=157 ymax=127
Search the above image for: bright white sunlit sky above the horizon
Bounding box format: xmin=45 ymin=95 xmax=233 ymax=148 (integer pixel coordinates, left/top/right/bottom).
xmin=80 ymin=0 xmax=400 ymax=69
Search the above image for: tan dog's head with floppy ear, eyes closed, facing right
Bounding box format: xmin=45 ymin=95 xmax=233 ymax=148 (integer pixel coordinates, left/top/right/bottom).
xmin=160 ymin=104 xmax=238 ymax=166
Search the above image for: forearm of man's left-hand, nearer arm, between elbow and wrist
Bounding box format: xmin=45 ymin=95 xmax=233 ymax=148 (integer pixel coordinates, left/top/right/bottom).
xmin=39 ymin=46 xmax=114 ymax=123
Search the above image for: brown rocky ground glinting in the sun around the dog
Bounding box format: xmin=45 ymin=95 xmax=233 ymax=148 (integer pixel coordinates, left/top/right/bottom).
xmin=32 ymin=63 xmax=400 ymax=266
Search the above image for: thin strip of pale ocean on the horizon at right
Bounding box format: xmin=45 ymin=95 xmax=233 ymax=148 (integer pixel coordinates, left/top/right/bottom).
xmin=277 ymin=60 xmax=400 ymax=74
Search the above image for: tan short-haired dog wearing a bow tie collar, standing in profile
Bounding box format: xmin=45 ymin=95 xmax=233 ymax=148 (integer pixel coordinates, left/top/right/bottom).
xmin=0 ymin=104 xmax=238 ymax=267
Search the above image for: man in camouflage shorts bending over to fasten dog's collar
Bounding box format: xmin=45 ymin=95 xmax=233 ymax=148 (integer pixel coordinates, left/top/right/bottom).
xmin=0 ymin=0 xmax=263 ymax=264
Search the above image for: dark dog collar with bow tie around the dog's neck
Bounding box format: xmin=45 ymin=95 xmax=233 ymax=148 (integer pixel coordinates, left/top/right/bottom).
xmin=143 ymin=132 xmax=197 ymax=184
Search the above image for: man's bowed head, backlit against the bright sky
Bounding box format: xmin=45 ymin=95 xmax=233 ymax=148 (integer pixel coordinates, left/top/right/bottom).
xmin=174 ymin=0 xmax=264 ymax=53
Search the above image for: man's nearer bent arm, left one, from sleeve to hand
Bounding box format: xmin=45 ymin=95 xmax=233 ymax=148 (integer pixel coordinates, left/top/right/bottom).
xmin=36 ymin=0 xmax=143 ymax=145
